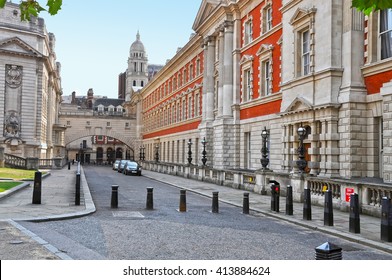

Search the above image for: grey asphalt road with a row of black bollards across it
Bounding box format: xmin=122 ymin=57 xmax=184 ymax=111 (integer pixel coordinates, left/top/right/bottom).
xmin=21 ymin=166 xmax=392 ymax=260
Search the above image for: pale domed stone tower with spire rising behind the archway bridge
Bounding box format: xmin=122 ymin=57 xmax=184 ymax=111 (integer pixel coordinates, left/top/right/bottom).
xmin=126 ymin=31 xmax=148 ymax=94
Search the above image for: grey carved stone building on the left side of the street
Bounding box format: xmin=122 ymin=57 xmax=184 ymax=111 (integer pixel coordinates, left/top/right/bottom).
xmin=0 ymin=2 xmax=65 ymax=159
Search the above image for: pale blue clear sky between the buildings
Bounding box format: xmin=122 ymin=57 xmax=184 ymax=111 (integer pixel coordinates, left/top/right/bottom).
xmin=38 ymin=0 xmax=202 ymax=98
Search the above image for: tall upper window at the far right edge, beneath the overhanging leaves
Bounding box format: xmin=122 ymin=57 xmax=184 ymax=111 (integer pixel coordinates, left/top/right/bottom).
xmin=380 ymin=9 xmax=392 ymax=59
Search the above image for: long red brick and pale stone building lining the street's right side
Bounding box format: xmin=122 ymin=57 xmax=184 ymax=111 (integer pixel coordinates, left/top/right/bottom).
xmin=128 ymin=0 xmax=392 ymax=215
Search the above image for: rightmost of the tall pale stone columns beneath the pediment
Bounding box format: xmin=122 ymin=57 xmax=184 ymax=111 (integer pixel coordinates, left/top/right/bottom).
xmin=223 ymin=21 xmax=234 ymax=116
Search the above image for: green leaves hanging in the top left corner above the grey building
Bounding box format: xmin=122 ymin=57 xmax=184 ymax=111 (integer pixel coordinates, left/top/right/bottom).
xmin=0 ymin=0 xmax=63 ymax=21
